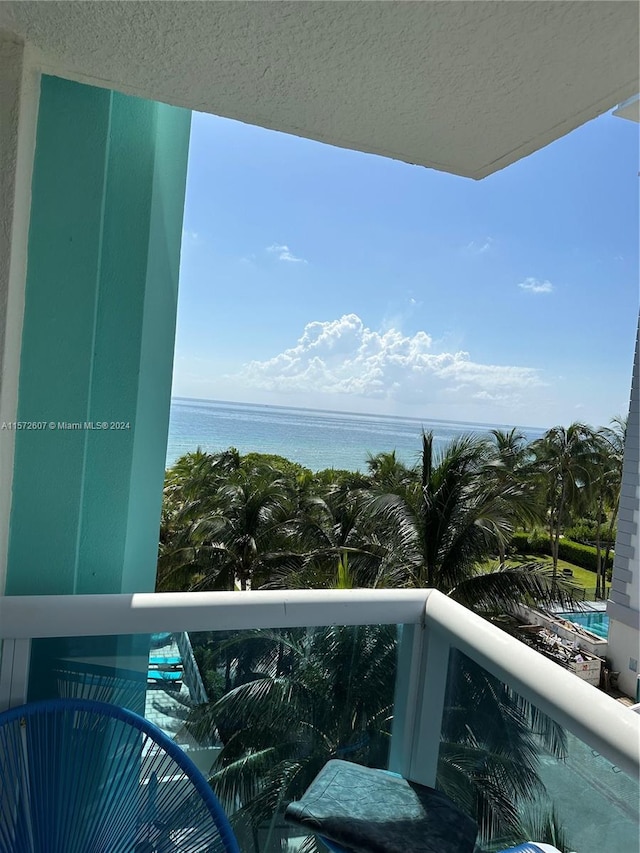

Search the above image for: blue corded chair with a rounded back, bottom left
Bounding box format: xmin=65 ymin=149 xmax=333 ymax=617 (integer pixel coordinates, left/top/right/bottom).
xmin=0 ymin=698 xmax=240 ymax=853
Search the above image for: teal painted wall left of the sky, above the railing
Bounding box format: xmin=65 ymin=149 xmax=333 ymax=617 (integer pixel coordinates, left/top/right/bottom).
xmin=6 ymin=77 xmax=190 ymax=595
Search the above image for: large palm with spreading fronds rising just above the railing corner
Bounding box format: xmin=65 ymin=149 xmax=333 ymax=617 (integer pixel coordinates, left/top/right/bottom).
xmin=370 ymin=433 xmax=563 ymax=612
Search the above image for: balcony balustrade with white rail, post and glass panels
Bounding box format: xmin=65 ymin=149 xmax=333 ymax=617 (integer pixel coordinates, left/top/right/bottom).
xmin=0 ymin=590 xmax=640 ymax=853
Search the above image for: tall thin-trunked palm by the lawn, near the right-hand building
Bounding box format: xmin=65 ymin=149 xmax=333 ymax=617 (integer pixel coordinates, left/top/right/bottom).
xmin=531 ymin=423 xmax=597 ymax=587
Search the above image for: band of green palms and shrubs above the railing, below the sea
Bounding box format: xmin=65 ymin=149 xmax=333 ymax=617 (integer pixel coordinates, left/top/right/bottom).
xmin=158 ymin=420 xmax=624 ymax=613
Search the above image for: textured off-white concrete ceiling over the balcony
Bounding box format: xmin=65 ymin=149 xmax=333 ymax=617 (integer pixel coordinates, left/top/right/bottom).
xmin=0 ymin=0 xmax=639 ymax=178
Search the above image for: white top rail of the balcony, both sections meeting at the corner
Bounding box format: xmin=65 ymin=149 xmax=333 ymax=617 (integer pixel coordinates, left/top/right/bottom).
xmin=0 ymin=589 xmax=640 ymax=776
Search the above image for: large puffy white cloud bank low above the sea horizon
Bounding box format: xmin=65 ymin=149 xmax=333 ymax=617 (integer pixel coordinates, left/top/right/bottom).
xmin=232 ymin=314 xmax=544 ymax=405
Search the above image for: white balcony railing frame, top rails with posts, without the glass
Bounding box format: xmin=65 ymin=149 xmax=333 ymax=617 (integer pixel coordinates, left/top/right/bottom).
xmin=0 ymin=590 xmax=640 ymax=785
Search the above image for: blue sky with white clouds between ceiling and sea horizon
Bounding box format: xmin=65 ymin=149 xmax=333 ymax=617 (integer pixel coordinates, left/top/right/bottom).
xmin=173 ymin=108 xmax=639 ymax=427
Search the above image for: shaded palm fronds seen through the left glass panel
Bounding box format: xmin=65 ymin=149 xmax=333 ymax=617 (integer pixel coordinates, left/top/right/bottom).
xmin=192 ymin=625 xmax=396 ymax=848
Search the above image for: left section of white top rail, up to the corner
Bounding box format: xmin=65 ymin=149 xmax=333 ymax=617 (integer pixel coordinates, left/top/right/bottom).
xmin=0 ymin=589 xmax=430 ymax=639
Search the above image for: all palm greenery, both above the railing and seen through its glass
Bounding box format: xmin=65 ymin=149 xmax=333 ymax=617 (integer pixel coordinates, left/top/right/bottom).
xmin=158 ymin=424 xmax=623 ymax=849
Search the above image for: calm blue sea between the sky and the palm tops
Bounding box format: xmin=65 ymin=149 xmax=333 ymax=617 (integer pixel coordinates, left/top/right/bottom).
xmin=167 ymin=397 xmax=544 ymax=471
